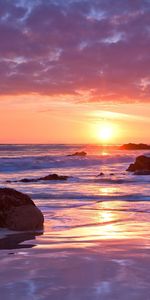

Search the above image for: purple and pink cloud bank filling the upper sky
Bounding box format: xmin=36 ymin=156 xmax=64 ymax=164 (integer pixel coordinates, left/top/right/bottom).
xmin=0 ymin=0 xmax=150 ymax=102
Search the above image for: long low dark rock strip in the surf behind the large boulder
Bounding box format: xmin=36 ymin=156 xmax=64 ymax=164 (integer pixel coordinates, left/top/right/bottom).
xmin=6 ymin=174 xmax=69 ymax=183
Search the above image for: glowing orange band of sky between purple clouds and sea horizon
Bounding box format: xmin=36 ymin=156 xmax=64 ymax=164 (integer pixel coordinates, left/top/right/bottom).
xmin=0 ymin=95 xmax=150 ymax=144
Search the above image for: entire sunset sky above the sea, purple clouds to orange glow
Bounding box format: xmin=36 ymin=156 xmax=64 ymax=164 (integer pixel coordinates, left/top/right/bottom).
xmin=0 ymin=0 xmax=150 ymax=144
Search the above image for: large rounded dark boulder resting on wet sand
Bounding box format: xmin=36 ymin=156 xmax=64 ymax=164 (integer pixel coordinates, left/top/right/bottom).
xmin=0 ymin=188 xmax=44 ymax=231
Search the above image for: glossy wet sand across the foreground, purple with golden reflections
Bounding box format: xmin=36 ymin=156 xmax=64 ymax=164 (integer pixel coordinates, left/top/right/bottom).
xmin=0 ymin=201 xmax=150 ymax=300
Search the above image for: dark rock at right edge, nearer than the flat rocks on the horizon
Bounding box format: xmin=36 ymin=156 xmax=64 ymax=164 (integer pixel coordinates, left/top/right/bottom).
xmin=127 ymin=155 xmax=150 ymax=175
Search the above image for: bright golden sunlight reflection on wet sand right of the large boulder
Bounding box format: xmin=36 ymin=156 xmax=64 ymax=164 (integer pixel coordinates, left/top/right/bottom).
xmin=37 ymin=201 xmax=150 ymax=253
